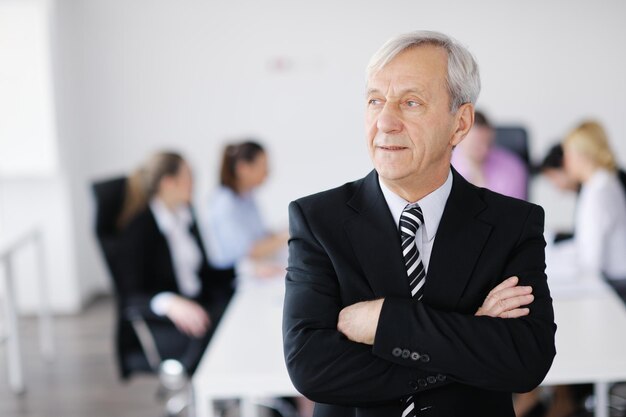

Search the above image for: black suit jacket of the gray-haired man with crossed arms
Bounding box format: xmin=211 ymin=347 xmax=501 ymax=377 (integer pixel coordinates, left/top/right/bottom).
xmin=283 ymin=170 xmax=556 ymax=417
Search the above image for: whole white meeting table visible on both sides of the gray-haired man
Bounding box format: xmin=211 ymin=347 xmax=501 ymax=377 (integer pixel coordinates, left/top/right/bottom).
xmin=193 ymin=280 xmax=626 ymax=417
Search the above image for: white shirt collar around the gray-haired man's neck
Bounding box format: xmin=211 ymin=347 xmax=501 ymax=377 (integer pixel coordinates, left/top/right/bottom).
xmin=378 ymin=171 xmax=452 ymax=241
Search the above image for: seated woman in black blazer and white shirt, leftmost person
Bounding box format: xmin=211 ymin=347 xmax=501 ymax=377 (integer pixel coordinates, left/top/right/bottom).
xmin=116 ymin=152 xmax=232 ymax=375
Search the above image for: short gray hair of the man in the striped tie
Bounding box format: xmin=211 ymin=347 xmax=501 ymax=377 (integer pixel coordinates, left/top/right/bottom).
xmin=367 ymin=30 xmax=480 ymax=112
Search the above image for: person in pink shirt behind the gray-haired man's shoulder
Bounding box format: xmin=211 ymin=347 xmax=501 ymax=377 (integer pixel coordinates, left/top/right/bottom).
xmin=452 ymin=111 xmax=528 ymax=200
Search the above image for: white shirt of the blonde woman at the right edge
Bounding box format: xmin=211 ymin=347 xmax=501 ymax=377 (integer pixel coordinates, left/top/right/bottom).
xmin=574 ymin=169 xmax=626 ymax=278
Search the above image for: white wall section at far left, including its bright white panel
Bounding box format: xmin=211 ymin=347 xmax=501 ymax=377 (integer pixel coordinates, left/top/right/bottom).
xmin=0 ymin=0 xmax=84 ymax=313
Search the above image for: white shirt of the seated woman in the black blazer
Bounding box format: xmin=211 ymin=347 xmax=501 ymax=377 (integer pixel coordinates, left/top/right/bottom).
xmin=150 ymin=198 xmax=202 ymax=316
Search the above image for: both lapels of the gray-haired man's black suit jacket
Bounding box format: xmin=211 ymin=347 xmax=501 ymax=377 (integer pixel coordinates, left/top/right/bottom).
xmin=345 ymin=168 xmax=491 ymax=309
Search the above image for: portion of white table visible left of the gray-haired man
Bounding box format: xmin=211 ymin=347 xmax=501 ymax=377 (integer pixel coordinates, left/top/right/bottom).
xmin=192 ymin=279 xmax=299 ymax=417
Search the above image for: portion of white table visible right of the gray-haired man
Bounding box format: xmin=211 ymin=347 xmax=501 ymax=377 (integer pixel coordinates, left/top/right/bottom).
xmin=543 ymin=279 xmax=626 ymax=417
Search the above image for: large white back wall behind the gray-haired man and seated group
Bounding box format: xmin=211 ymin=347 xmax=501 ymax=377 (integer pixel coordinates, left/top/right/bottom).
xmin=47 ymin=0 xmax=626 ymax=302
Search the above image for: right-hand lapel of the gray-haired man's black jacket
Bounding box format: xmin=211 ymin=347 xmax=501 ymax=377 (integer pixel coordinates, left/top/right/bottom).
xmin=424 ymin=169 xmax=491 ymax=309
